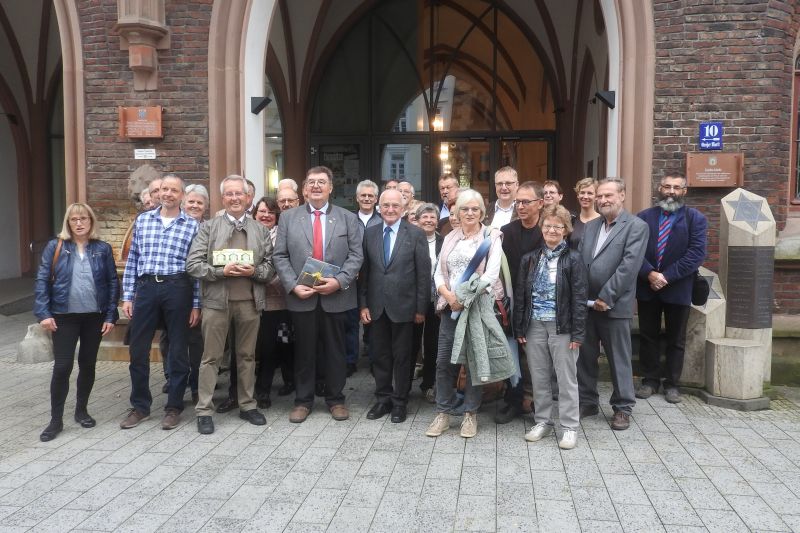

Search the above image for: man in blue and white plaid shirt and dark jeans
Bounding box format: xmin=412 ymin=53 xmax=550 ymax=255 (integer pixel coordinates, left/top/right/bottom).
xmin=120 ymin=175 xmax=200 ymax=429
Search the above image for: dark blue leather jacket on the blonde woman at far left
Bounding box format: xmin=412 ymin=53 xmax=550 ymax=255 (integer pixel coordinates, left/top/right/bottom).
xmin=33 ymin=239 xmax=119 ymax=324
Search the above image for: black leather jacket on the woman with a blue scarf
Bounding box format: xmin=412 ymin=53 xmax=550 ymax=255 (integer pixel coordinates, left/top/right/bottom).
xmin=513 ymin=246 xmax=589 ymax=343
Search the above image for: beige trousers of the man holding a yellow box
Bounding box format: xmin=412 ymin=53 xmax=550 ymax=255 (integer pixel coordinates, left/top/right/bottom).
xmin=195 ymin=300 xmax=261 ymax=416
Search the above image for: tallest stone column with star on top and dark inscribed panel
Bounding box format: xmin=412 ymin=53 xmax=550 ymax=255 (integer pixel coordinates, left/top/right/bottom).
xmin=719 ymin=189 xmax=776 ymax=382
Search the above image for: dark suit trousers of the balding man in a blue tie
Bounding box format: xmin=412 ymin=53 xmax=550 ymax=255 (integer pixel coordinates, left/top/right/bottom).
xmin=370 ymin=313 xmax=414 ymax=406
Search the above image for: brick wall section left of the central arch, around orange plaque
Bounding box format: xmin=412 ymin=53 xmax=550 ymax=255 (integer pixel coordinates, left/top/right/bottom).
xmin=78 ymin=0 xmax=213 ymax=250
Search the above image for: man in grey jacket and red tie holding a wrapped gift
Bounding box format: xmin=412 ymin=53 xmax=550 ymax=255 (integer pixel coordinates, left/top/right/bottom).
xmin=273 ymin=167 xmax=364 ymax=423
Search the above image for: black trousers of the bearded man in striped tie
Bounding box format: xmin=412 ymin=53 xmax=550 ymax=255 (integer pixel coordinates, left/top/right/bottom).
xmin=638 ymin=299 xmax=689 ymax=389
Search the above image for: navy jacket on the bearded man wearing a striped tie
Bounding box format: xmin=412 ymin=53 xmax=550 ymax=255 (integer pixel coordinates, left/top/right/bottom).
xmin=636 ymin=206 xmax=708 ymax=305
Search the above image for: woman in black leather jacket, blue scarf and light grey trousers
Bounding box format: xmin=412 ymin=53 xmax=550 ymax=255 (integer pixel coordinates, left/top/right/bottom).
xmin=514 ymin=204 xmax=588 ymax=450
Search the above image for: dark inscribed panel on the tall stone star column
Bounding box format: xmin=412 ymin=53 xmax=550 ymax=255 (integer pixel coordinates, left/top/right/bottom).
xmin=726 ymin=246 xmax=775 ymax=329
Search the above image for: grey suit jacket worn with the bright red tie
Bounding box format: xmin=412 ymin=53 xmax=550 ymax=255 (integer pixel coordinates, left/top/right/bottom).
xmin=272 ymin=203 xmax=364 ymax=313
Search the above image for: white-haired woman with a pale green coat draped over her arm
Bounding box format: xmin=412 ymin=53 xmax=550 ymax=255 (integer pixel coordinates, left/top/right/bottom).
xmin=425 ymin=189 xmax=516 ymax=438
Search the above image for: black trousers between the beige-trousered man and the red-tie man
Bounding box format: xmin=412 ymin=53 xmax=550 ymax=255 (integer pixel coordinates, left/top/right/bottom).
xmin=256 ymin=309 xmax=294 ymax=396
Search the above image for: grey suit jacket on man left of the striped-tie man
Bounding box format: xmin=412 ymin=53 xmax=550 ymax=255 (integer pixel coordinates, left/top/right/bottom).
xmin=578 ymin=209 xmax=648 ymax=318
